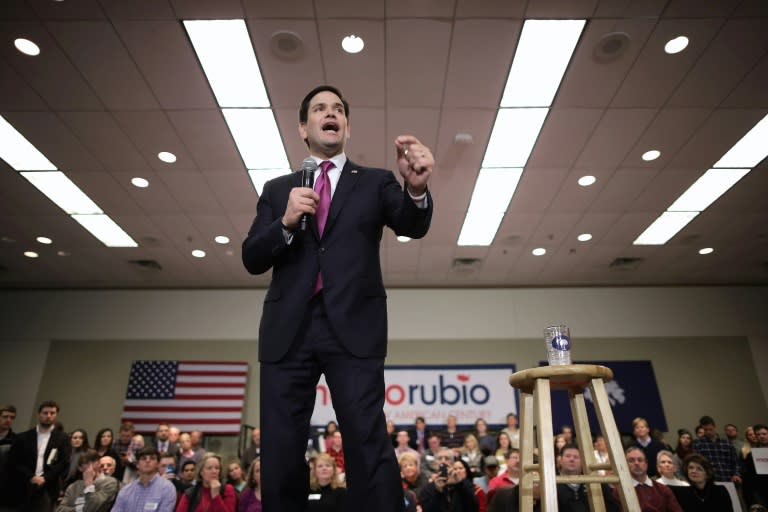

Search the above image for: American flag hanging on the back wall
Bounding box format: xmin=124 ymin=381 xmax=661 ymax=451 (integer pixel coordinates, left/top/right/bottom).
xmin=122 ymin=361 xmax=248 ymax=434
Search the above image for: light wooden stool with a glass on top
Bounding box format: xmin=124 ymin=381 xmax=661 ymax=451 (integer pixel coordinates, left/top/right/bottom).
xmin=509 ymin=364 xmax=640 ymax=512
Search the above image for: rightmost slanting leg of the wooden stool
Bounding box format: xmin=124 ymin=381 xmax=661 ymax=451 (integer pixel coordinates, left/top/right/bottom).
xmin=590 ymin=379 xmax=640 ymax=510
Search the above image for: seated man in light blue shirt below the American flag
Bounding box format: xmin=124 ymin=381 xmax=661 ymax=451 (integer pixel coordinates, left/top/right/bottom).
xmin=112 ymin=446 xmax=176 ymax=512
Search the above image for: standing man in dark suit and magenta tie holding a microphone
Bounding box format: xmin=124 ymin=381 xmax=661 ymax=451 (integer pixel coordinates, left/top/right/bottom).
xmin=243 ymin=86 xmax=434 ymax=512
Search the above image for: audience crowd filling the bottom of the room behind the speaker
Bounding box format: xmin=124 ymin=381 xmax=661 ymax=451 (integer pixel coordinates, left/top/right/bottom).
xmin=0 ymin=401 xmax=768 ymax=512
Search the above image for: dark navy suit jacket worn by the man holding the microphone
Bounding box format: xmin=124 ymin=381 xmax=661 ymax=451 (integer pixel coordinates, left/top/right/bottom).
xmin=243 ymin=160 xmax=432 ymax=362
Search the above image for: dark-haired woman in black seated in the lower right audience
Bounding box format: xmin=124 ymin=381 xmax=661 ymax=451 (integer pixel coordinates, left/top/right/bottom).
xmin=670 ymin=453 xmax=733 ymax=512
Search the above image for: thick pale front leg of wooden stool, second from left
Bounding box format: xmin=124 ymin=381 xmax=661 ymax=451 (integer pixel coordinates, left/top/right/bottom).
xmin=533 ymin=379 xmax=557 ymax=512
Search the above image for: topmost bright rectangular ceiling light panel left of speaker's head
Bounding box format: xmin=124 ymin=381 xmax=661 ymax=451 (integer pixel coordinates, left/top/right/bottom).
xmin=184 ymin=20 xmax=269 ymax=108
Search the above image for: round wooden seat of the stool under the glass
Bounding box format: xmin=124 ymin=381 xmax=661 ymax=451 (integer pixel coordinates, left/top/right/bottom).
xmin=509 ymin=364 xmax=613 ymax=393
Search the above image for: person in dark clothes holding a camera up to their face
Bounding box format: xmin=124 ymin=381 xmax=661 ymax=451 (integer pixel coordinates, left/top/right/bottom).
xmin=419 ymin=447 xmax=479 ymax=512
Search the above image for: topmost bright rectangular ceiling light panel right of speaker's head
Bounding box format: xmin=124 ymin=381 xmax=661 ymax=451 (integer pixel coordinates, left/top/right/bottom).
xmin=501 ymin=20 xmax=586 ymax=108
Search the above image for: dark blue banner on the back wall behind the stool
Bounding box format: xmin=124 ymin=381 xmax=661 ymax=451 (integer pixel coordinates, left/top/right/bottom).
xmin=539 ymin=361 xmax=667 ymax=434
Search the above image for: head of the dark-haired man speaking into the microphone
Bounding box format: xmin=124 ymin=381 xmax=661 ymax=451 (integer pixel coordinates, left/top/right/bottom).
xmin=299 ymin=91 xmax=349 ymax=156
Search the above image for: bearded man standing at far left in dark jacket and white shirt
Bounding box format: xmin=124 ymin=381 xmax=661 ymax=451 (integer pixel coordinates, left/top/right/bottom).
xmin=8 ymin=401 xmax=70 ymax=512
